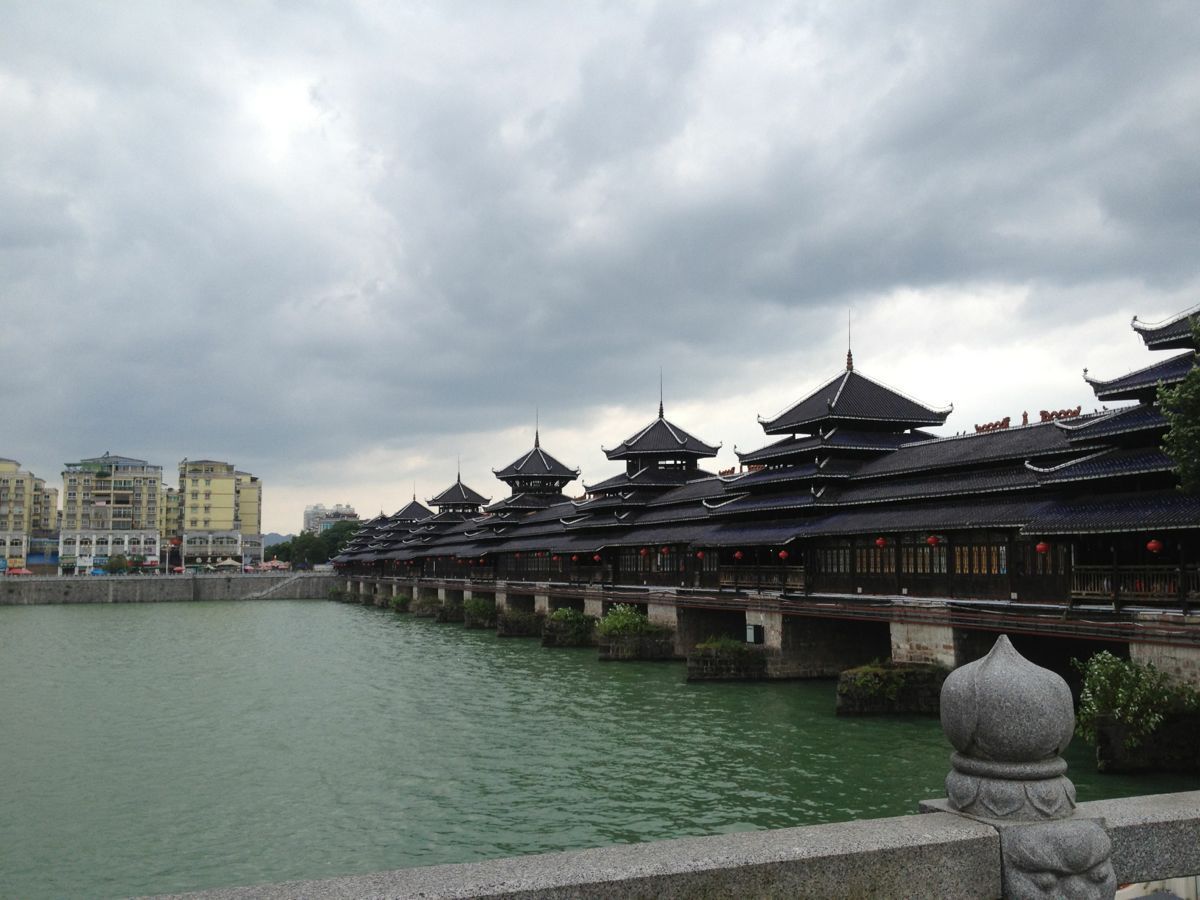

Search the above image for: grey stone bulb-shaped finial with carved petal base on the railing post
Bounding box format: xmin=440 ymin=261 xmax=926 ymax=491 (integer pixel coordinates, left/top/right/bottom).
xmin=942 ymin=635 xmax=1075 ymax=822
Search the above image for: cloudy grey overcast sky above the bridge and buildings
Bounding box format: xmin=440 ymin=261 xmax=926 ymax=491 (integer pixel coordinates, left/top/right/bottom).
xmin=0 ymin=0 xmax=1200 ymax=532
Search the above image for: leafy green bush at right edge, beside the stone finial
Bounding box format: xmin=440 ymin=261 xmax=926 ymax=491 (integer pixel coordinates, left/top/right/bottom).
xmin=1070 ymin=650 xmax=1200 ymax=748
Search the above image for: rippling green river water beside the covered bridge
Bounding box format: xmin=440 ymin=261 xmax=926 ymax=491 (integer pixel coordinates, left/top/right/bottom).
xmin=0 ymin=601 xmax=1200 ymax=898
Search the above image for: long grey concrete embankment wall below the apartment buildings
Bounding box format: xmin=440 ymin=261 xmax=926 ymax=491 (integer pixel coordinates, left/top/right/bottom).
xmin=0 ymin=572 xmax=340 ymax=606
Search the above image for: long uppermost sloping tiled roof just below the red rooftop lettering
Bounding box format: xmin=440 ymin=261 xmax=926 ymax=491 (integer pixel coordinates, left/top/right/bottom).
xmin=856 ymin=422 xmax=1079 ymax=478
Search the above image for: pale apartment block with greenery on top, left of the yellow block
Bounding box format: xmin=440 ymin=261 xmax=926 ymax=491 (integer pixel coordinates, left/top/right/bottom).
xmin=59 ymin=451 xmax=162 ymax=574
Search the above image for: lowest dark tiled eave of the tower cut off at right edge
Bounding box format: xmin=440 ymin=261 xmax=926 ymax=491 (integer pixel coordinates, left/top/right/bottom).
xmin=1022 ymin=491 xmax=1200 ymax=535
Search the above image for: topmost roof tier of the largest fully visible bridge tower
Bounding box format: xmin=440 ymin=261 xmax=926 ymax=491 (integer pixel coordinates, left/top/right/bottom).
xmin=758 ymin=368 xmax=952 ymax=434
